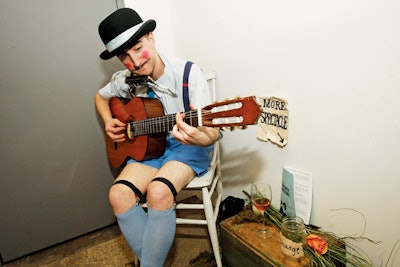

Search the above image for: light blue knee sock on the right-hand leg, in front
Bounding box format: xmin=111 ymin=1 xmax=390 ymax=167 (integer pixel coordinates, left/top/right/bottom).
xmin=140 ymin=207 xmax=176 ymax=267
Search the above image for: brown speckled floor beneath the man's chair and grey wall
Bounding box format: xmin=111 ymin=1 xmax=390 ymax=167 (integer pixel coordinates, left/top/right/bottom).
xmin=4 ymin=195 xmax=216 ymax=267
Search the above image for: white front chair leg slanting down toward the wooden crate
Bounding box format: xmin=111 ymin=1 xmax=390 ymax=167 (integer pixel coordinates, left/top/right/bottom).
xmin=202 ymin=188 xmax=222 ymax=267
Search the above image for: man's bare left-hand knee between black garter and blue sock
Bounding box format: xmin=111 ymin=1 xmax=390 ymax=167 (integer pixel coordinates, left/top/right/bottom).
xmin=108 ymin=184 xmax=136 ymax=214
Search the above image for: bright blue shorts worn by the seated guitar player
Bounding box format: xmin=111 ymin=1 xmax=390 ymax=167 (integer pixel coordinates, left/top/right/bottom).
xmin=127 ymin=136 xmax=214 ymax=176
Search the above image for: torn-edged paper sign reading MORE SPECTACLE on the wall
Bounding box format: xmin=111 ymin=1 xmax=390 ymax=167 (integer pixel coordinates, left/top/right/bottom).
xmin=257 ymin=97 xmax=289 ymax=147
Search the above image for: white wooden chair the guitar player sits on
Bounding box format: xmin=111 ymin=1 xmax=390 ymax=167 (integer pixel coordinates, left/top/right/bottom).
xmin=175 ymin=71 xmax=223 ymax=267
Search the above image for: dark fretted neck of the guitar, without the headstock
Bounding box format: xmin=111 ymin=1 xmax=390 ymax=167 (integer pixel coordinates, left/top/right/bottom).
xmin=127 ymin=110 xmax=201 ymax=137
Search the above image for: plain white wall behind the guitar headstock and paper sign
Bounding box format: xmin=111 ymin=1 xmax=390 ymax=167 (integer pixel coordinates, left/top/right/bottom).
xmin=126 ymin=0 xmax=400 ymax=266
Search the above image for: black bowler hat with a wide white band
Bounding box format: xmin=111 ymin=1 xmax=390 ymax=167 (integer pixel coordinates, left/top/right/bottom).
xmin=99 ymin=8 xmax=156 ymax=59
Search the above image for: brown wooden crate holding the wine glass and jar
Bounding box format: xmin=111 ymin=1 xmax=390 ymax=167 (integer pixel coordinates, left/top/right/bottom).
xmin=220 ymin=216 xmax=344 ymax=267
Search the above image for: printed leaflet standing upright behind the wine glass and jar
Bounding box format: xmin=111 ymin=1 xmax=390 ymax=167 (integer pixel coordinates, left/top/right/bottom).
xmin=280 ymin=167 xmax=312 ymax=224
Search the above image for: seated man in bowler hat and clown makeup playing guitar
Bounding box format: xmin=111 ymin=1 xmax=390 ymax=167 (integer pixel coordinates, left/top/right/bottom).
xmin=95 ymin=8 xmax=220 ymax=267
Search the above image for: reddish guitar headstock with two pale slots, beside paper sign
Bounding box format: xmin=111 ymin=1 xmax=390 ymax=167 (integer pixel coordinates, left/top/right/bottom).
xmin=202 ymin=96 xmax=261 ymax=128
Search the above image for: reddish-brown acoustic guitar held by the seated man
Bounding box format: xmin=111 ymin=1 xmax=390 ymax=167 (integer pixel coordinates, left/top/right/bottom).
xmin=106 ymin=96 xmax=261 ymax=168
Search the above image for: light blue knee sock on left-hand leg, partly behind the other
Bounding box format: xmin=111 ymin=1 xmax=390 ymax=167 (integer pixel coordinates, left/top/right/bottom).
xmin=115 ymin=205 xmax=148 ymax=260
